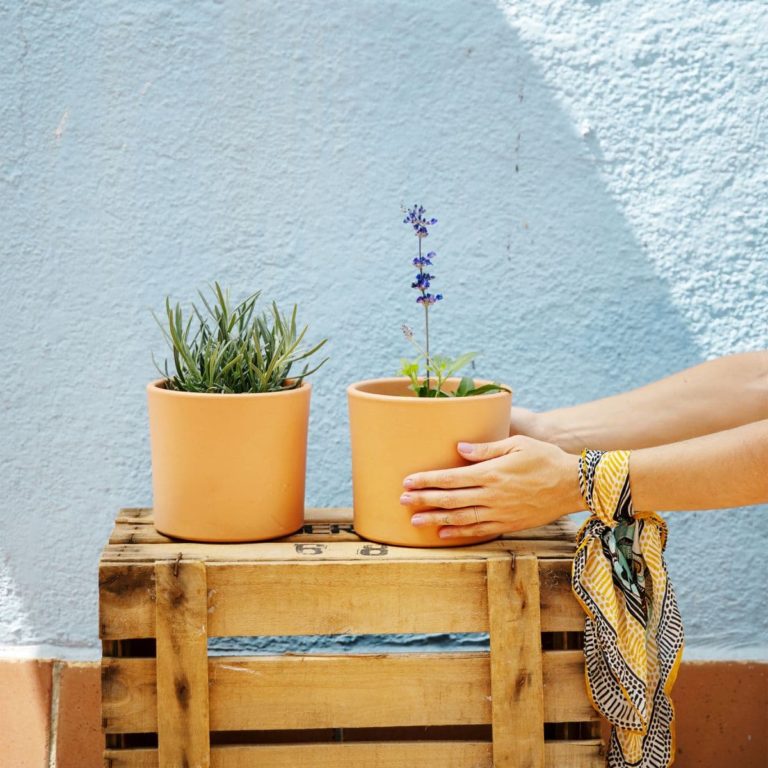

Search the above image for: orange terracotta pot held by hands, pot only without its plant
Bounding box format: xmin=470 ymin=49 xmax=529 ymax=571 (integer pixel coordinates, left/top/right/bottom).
xmin=347 ymin=378 xmax=512 ymax=547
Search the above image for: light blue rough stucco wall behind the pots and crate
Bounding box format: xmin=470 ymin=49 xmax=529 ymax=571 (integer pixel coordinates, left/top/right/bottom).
xmin=0 ymin=0 xmax=768 ymax=659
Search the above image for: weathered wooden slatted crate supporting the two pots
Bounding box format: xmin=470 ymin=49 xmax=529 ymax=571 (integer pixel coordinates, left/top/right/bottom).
xmin=99 ymin=509 xmax=604 ymax=768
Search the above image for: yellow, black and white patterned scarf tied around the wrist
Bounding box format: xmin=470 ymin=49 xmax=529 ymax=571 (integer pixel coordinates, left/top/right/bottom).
xmin=572 ymin=450 xmax=683 ymax=768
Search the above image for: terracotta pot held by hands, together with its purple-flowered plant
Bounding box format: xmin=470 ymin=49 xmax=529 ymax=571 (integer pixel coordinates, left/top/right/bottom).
xmin=347 ymin=206 xmax=512 ymax=547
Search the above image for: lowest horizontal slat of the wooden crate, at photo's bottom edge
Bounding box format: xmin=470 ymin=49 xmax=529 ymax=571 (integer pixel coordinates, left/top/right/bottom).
xmin=104 ymin=740 xmax=605 ymax=768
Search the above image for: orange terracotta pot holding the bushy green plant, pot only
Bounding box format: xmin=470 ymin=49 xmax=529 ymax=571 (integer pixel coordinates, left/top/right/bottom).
xmin=147 ymin=379 xmax=311 ymax=541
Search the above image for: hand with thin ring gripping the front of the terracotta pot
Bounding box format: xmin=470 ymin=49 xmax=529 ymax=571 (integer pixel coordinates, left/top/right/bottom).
xmin=400 ymin=435 xmax=583 ymax=539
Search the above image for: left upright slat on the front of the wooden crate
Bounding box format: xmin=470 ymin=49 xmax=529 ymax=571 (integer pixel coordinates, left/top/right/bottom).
xmin=155 ymin=562 xmax=210 ymax=768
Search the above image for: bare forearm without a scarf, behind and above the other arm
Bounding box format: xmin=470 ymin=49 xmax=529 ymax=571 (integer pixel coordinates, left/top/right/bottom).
xmin=536 ymin=351 xmax=768 ymax=453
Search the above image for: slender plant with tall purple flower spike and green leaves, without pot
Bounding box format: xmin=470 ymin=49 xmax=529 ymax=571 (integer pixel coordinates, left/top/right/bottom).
xmin=400 ymin=205 xmax=509 ymax=397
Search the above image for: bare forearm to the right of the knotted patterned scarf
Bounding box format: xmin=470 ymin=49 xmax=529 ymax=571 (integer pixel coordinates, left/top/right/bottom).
xmin=629 ymin=419 xmax=768 ymax=511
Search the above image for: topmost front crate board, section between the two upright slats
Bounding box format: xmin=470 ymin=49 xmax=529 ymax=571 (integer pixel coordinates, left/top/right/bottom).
xmin=209 ymin=561 xmax=488 ymax=636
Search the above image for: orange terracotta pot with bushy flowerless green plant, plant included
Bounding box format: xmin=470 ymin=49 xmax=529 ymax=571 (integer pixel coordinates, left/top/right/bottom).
xmin=147 ymin=283 xmax=325 ymax=542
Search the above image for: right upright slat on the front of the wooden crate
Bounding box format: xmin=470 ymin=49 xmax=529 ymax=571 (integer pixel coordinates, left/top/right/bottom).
xmin=488 ymin=555 xmax=544 ymax=768
